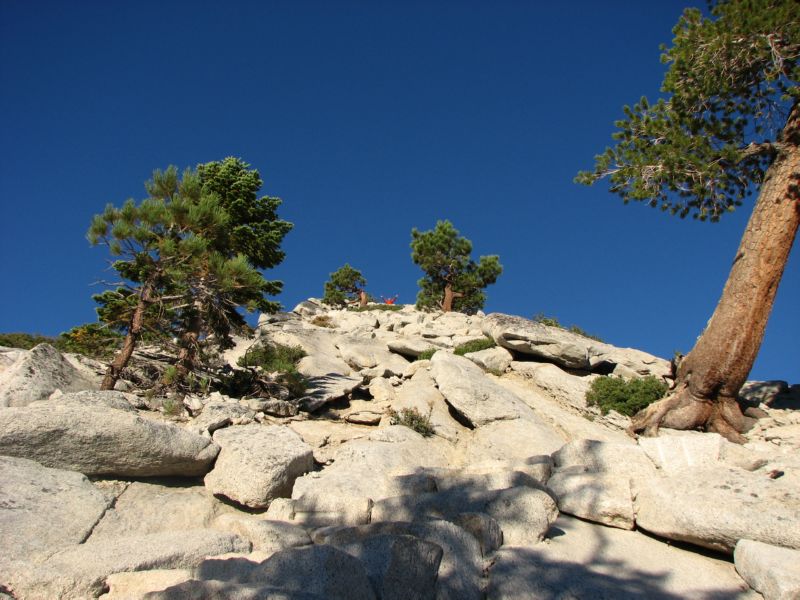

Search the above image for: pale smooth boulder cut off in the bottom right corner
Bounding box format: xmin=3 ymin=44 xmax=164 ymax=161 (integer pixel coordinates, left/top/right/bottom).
xmin=733 ymin=540 xmax=800 ymax=600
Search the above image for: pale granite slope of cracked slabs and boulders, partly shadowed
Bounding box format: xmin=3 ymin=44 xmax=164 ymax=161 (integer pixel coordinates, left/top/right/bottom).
xmin=0 ymin=300 xmax=800 ymax=600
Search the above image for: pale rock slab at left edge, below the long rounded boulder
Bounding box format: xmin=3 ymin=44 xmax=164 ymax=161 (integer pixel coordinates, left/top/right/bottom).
xmin=0 ymin=456 xmax=109 ymax=568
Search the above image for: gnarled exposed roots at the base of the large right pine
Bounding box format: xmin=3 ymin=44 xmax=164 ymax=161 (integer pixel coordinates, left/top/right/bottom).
xmin=628 ymin=386 xmax=747 ymax=444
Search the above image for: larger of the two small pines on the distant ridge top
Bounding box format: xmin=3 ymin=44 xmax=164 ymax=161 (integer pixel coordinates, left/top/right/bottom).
xmin=411 ymin=221 xmax=503 ymax=314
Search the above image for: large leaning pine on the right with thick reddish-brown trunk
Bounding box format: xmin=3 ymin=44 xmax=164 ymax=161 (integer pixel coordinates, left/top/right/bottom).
xmin=577 ymin=0 xmax=800 ymax=442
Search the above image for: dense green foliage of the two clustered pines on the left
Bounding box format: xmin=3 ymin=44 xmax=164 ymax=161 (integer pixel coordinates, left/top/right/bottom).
xmin=87 ymin=158 xmax=292 ymax=385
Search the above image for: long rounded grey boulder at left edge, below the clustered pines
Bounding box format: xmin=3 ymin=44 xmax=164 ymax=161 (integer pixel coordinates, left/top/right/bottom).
xmin=0 ymin=402 xmax=218 ymax=477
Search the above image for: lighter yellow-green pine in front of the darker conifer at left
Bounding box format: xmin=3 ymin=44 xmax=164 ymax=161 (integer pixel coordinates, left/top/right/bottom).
xmin=88 ymin=162 xmax=291 ymax=389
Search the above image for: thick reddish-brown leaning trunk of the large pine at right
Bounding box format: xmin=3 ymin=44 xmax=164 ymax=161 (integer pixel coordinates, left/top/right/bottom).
xmin=631 ymin=107 xmax=800 ymax=442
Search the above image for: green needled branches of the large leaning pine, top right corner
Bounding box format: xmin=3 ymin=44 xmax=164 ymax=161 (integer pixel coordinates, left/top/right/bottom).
xmin=576 ymin=0 xmax=800 ymax=221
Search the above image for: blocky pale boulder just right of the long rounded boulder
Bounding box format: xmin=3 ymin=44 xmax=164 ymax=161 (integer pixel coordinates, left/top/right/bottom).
xmin=205 ymin=424 xmax=314 ymax=508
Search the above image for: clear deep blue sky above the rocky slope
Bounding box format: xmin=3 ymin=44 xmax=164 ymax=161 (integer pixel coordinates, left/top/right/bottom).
xmin=0 ymin=0 xmax=800 ymax=382
